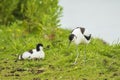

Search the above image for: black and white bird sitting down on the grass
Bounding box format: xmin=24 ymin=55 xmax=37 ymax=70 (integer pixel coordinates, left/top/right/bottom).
xmin=18 ymin=44 xmax=45 ymax=59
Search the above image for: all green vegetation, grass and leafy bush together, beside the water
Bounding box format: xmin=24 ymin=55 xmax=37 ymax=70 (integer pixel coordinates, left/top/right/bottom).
xmin=0 ymin=0 xmax=120 ymax=80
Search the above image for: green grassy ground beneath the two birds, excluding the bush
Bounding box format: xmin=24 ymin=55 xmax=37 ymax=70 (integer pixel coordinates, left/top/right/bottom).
xmin=0 ymin=26 xmax=120 ymax=80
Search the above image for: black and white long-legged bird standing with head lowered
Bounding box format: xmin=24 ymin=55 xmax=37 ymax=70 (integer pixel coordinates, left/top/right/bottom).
xmin=69 ymin=27 xmax=91 ymax=63
